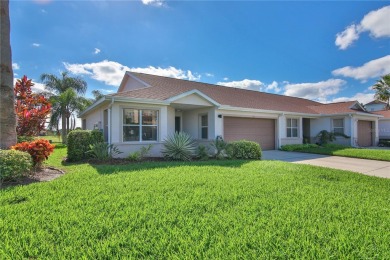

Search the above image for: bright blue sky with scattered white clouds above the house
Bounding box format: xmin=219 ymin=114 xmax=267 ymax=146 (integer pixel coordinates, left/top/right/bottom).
xmin=10 ymin=0 xmax=390 ymax=103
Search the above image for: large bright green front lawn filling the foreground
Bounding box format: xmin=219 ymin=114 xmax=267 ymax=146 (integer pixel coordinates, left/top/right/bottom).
xmin=0 ymin=145 xmax=390 ymax=259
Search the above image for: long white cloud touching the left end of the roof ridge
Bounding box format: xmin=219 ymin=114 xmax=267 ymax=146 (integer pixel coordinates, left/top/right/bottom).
xmin=64 ymin=60 xmax=201 ymax=86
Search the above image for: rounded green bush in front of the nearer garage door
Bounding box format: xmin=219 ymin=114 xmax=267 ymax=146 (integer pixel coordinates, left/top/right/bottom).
xmin=227 ymin=140 xmax=261 ymax=159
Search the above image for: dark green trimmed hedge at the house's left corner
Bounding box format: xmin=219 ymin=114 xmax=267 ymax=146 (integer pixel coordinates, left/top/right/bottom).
xmin=68 ymin=130 xmax=104 ymax=162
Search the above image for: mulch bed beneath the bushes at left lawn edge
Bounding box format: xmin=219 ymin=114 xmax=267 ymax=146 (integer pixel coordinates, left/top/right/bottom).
xmin=0 ymin=167 xmax=65 ymax=189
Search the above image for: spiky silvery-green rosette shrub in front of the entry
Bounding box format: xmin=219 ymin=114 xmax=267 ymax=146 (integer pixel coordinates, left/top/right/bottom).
xmin=161 ymin=132 xmax=195 ymax=161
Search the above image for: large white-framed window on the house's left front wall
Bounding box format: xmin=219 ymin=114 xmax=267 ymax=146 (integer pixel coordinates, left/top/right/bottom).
xmin=123 ymin=108 xmax=158 ymax=142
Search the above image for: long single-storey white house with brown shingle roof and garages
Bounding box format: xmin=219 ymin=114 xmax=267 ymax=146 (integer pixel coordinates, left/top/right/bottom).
xmin=80 ymin=72 xmax=381 ymax=156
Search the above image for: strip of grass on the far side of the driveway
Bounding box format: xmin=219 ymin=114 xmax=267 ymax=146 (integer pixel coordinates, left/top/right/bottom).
xmin=296 ymin=147 xmax=390 ymax=161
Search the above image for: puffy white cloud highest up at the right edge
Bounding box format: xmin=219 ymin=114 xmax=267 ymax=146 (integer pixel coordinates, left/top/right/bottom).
xmin=335 ymin=6 xmax=390 ymax=50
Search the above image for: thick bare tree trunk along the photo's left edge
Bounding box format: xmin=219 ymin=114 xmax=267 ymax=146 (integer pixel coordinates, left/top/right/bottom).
xmin=0 ymin=0 xmax=16 ymax=149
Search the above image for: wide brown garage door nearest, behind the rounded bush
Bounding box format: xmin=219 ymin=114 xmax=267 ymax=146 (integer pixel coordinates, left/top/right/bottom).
xmin=223 ymin=117 xmax=275 ymax=150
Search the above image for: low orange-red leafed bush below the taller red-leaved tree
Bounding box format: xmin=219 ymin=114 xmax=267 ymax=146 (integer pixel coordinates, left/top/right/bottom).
xmin=11 ymin=139 xmax=55 ymax=168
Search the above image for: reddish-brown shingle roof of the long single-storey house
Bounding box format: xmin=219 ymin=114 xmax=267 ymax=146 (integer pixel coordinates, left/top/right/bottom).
xmin=111 ymin=72 xmax=374 ymax=114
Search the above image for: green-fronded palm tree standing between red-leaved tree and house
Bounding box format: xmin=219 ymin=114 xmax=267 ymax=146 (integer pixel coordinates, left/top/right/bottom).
xmin=41 ymin=71 xmax=87 ymax=143
